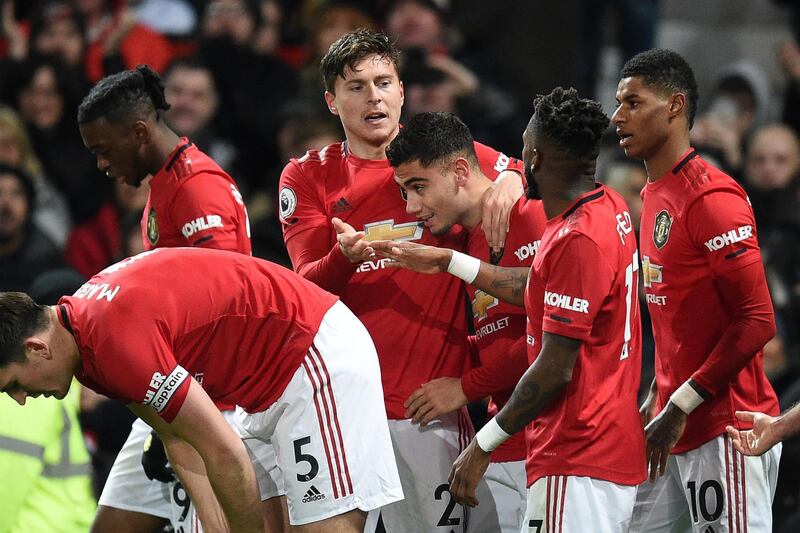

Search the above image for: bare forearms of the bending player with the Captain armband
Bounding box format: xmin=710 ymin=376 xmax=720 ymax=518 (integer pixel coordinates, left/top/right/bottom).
xmin=129 ymin=380 xmax=264 ymax=532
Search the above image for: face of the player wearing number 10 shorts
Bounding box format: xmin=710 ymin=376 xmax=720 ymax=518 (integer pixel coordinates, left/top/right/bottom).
xmin=611 ymin=76 xmax=670 ymax=161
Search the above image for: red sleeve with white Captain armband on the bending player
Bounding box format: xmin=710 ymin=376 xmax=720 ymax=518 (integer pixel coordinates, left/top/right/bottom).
xmin=94 ymin=324 xmax=191 ymax=422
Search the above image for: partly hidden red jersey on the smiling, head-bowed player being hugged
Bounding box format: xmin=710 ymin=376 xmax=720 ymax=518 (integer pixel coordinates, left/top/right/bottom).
xmin=461 ymin=197 xmax=547 ymax=463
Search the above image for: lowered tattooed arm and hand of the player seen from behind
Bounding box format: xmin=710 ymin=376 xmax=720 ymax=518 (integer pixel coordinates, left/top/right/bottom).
xmin=449 ymin=333 xmax=582 ymax=507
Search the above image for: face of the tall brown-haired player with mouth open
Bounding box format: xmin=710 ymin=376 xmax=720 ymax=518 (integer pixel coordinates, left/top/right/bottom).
xmin=325 ymin=55 xmax=403 ymax=151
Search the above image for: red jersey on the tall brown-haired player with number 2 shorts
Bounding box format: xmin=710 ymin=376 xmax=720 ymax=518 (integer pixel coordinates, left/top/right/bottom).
xmin=279 ymin=142 xmax=520 ymax=419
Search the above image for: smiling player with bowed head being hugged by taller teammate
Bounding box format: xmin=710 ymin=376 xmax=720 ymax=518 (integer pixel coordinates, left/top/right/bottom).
xmin=386 ymin=113 xmax=545 ymax=533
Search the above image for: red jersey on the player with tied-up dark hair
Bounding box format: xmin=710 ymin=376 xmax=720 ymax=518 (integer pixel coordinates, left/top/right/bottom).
xmin=142 ymin=137 xmax=251 ymax=255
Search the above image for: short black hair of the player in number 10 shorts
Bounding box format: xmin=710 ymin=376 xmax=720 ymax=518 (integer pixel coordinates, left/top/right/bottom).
xmin=621 ymin=48 xmax=697 ymax=129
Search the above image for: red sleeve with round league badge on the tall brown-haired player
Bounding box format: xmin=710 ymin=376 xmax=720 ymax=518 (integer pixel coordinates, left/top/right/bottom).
xmin=278 ymin=161 xmax=358 ymax=294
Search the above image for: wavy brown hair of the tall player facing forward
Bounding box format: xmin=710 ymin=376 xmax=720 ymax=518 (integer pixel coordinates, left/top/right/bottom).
xmin=319 ymin=28 xmax=400 ymax=92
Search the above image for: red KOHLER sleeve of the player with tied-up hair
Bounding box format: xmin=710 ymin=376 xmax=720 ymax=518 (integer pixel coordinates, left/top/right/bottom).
xmin=170 ymin=173 xmax=250 ymax=253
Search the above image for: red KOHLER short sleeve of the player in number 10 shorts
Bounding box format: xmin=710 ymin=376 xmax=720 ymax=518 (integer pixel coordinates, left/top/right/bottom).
xmin=686 ymin=191 xmax=761 ymax=276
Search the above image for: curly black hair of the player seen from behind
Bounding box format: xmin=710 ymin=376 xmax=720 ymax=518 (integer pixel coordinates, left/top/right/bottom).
xmin=528 ymin=87 xmax=609 ymax=159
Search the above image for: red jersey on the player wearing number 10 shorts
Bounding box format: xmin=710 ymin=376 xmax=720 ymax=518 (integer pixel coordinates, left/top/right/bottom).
xmin=640 ymin=150 xmax=779 ymax=453
